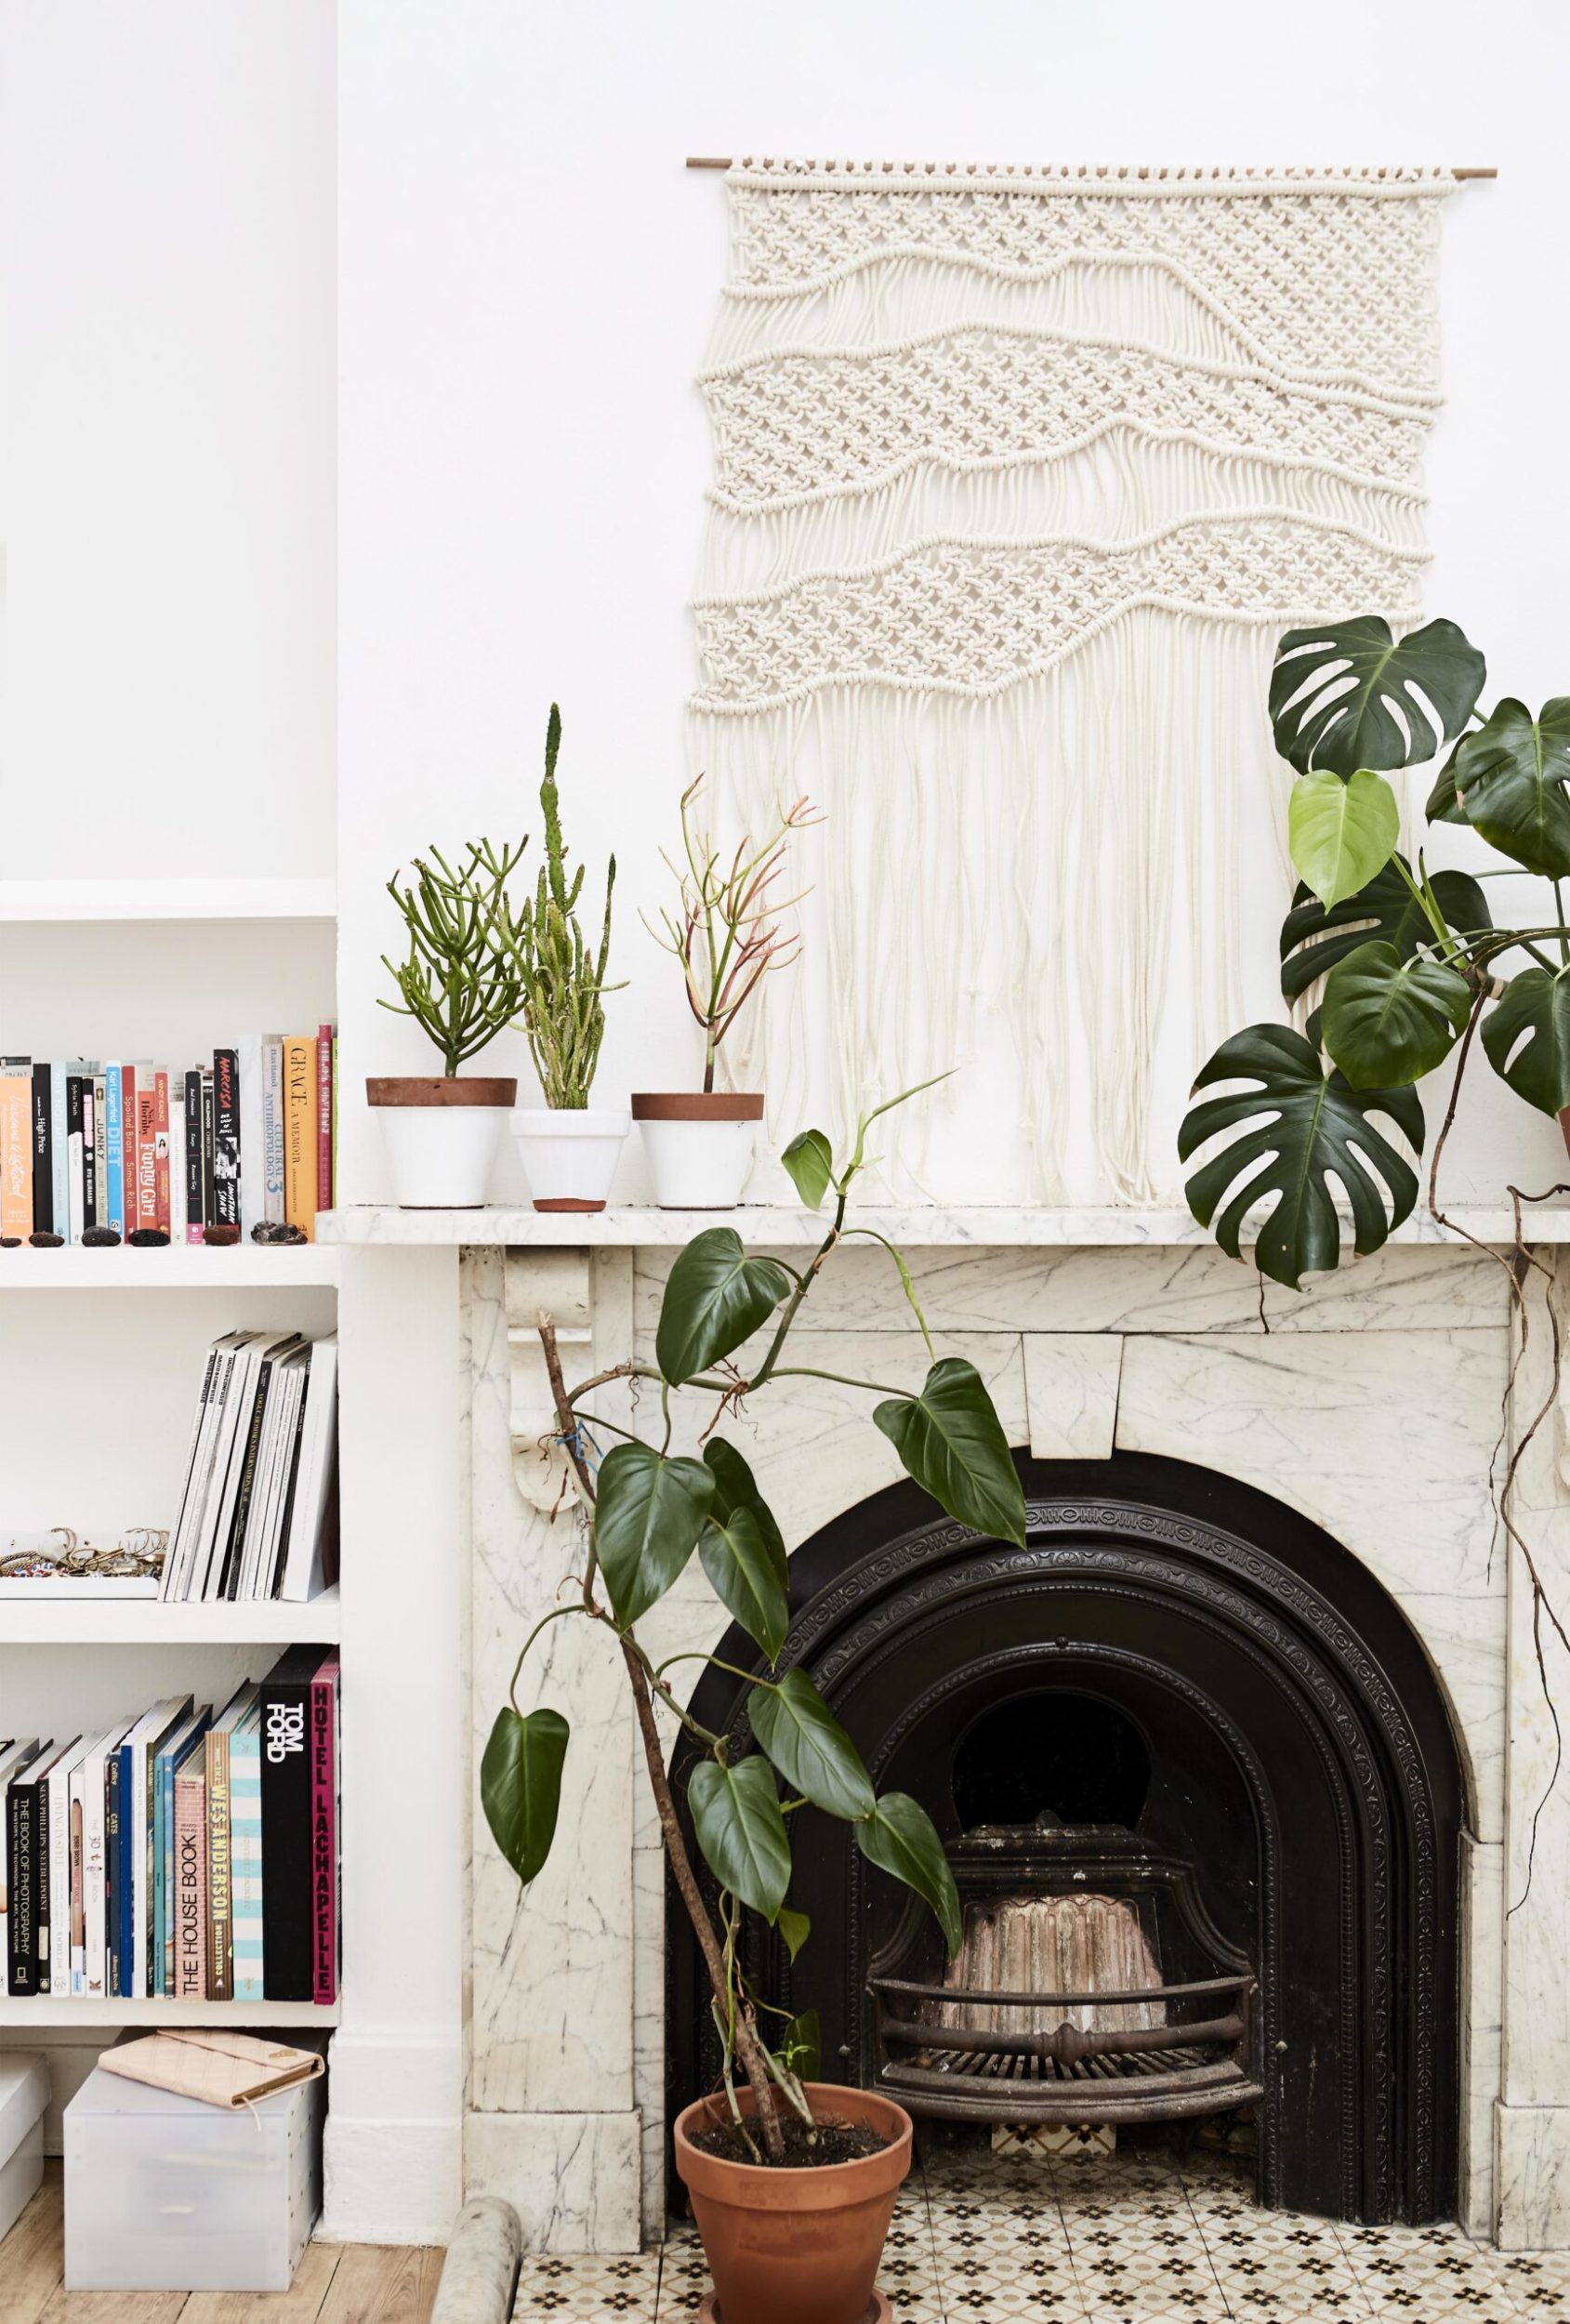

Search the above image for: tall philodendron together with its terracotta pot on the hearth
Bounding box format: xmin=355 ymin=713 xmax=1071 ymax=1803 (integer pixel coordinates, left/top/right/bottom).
xmin=481 ymin=1092 xmax=1024 ymax=2324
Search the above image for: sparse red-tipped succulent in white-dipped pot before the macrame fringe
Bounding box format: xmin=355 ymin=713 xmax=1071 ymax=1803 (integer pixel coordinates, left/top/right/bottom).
xmin=632 ymin=776 xmax=822 ymax=1211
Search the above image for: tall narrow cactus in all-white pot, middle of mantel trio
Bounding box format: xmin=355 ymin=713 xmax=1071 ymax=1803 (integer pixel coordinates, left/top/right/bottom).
xmin=495 ymin=702 xmax=632 ymax=1211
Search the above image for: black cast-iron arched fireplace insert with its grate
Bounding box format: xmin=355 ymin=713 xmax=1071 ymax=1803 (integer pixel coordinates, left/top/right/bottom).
xmin=666 ymin=1455 xmax=1463 ymax=2220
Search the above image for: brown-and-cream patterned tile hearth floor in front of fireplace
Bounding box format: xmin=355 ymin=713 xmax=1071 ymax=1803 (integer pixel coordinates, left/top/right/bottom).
xmin=513 ymin=2152 xmax=1570 ymax=2324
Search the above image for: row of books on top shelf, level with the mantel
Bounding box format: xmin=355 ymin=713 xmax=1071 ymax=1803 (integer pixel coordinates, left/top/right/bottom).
xmin=0 ymin=1025 xmax=336 ymax=1246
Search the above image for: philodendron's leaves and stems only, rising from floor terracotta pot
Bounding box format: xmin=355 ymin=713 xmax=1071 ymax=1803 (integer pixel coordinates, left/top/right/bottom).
xmin=481 ymin=1092 xmax=1024 ymax=2161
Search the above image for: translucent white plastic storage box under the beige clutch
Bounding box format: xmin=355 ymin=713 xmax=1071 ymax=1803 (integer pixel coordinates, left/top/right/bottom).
xmin=65 ymin=2067 xmax=327 ymax=2291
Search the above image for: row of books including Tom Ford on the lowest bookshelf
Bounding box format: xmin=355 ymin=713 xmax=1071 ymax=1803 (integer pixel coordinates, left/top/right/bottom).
xmin=0 ymin=1645 xmax=339 ymax=2006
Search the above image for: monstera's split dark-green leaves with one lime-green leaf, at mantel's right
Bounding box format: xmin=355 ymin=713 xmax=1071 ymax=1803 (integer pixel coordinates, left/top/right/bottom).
xmin=1178 ymin=618 xmax=1570 ymax=1287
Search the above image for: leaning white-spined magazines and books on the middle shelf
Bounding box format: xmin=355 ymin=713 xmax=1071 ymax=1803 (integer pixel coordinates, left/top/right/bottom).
xmin=160 ymin=1332 xmax=339 ymax=1602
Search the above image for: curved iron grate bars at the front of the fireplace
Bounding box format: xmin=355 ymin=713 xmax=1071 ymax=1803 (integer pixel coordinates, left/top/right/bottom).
xmin=873 ymin=1975 xmax=1263 ymax=2124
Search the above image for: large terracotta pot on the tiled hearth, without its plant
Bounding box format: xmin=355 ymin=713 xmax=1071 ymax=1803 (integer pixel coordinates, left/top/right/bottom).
xmin=676 ymin=2082 xmax=910 ymax=2324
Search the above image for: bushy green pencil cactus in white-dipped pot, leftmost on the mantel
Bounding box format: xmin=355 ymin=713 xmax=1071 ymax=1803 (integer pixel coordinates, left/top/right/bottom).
xmin=364 ymin=839 xmax=527 ymax=1211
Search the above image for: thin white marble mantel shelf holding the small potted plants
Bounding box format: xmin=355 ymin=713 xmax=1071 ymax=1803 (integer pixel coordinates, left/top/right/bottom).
xmin=316 ymin=1204 xmax=1570 ymax=1250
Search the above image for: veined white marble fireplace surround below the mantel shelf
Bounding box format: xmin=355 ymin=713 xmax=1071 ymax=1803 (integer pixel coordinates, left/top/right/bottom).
xmin=453 ymin=1213 xmax=1570 ymax=2252
